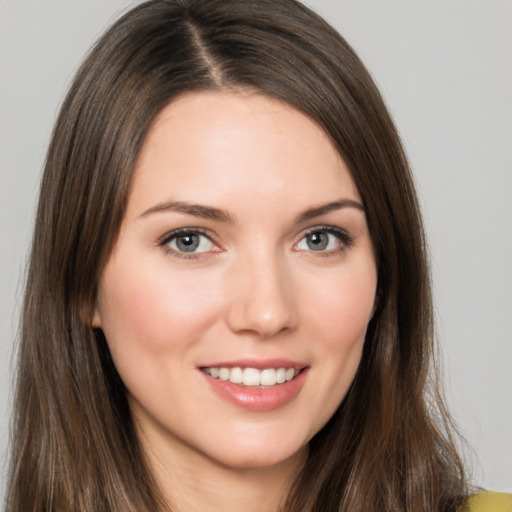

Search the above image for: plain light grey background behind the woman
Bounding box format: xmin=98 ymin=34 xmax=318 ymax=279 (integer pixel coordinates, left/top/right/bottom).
xmin=0 ymin=0 xmax=512 ymax=492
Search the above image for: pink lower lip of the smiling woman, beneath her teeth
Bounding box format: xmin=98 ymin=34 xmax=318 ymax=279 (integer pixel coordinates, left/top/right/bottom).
xmin=201 ymin=368 xmax=309 ymax=412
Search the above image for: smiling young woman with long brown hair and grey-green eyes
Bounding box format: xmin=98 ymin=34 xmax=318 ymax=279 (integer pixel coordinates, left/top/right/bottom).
xmin=7 ymin=0 xmax=508 ymax=511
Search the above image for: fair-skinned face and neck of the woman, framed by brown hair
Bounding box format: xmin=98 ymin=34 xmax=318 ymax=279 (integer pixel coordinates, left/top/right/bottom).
xmin=93 ymin=92 xmax=377 ymax=512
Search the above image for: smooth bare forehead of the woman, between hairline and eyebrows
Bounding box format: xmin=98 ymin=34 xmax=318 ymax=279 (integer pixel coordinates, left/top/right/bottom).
xmin=128 ymin=92 xmax=360 ymax=219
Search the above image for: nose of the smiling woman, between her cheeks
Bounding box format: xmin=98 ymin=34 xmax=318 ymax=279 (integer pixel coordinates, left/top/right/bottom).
xmin=227 ymin=250 xmax=298 ymax=338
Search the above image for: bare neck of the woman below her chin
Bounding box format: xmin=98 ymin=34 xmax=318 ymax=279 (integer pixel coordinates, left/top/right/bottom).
xmin=143 ymin=432 xmax=307 ymax=512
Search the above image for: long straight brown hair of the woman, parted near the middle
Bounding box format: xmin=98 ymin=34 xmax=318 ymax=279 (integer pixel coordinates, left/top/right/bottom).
xmin=6 ymin=0 xmax=467 ymax=512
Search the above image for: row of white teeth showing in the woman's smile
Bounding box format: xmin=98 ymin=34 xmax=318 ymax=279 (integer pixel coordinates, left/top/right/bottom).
xmin=202 ymin=366 xmax=299 ymax=386
